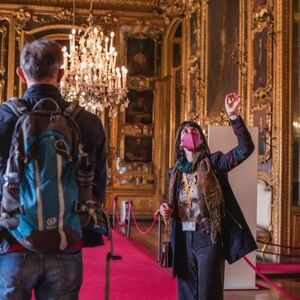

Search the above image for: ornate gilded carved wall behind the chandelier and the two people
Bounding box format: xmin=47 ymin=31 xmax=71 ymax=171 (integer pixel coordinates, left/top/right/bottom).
xmin=0 ymin=0 xmax=299 ymax=253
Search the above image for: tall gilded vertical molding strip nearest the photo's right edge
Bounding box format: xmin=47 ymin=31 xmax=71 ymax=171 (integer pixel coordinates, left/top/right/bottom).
xmin=272 ymin=1 xmax=292 ymax=252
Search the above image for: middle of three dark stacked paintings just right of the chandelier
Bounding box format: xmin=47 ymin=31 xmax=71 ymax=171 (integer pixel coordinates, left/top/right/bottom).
xmin=125 ymin=90 xmax=154 ymax=125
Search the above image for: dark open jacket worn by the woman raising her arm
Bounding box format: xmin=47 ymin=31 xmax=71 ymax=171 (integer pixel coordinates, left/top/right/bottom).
xmin=171 ymin=117 xmax=257 ymax=275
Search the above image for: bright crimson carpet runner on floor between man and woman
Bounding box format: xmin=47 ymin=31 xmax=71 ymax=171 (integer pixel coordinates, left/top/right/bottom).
xmin=79 ymin=231 xmax=176 ymax=300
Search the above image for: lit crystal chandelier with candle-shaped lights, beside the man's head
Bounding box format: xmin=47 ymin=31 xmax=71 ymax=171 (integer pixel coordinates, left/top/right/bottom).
xmin=60 ymin=8 xmax=129 ymax=117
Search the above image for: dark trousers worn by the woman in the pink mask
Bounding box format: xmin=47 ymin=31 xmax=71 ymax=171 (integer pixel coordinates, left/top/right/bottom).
xmin=176 ymin=230 xmax=225 ymax=300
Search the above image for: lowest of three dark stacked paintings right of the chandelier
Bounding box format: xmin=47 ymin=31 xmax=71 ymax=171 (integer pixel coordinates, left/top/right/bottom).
xmin=124 ymin=136 xmax=152 ymax=163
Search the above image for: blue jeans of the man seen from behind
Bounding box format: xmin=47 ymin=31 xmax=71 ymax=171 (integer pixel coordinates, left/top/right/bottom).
xmin=0 ymin=250 xmax=82 ymax=300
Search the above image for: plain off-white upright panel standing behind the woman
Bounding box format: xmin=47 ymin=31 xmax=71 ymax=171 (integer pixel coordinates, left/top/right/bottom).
xmin=208 ymin=126 xmax=258 ymax=289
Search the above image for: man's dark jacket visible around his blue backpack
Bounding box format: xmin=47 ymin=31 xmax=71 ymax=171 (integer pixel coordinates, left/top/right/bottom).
xmin=0 ymin=84 xmax=106 ymax=253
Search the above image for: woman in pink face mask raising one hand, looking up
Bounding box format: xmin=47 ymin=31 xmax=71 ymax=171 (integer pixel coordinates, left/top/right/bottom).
xmin=160 ymin=93 xmax=257 ymax=300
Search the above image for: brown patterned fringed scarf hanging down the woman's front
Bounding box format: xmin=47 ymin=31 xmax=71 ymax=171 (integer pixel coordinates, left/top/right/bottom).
xmin=169 ymin=157 xmax=225 ymax=244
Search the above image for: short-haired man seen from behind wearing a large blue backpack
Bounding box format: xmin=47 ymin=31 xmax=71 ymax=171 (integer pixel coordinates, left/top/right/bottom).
xmin=0 ymin=39 xmax=106 ymax=300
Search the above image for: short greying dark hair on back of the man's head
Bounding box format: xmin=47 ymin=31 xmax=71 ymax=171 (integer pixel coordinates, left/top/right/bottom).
xmin=21 ymin=39 xmax=63 ymax=80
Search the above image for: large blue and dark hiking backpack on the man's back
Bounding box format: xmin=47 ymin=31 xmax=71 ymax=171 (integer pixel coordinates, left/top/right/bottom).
xmin=0 ymin=98 xmax=95 ymax=252
